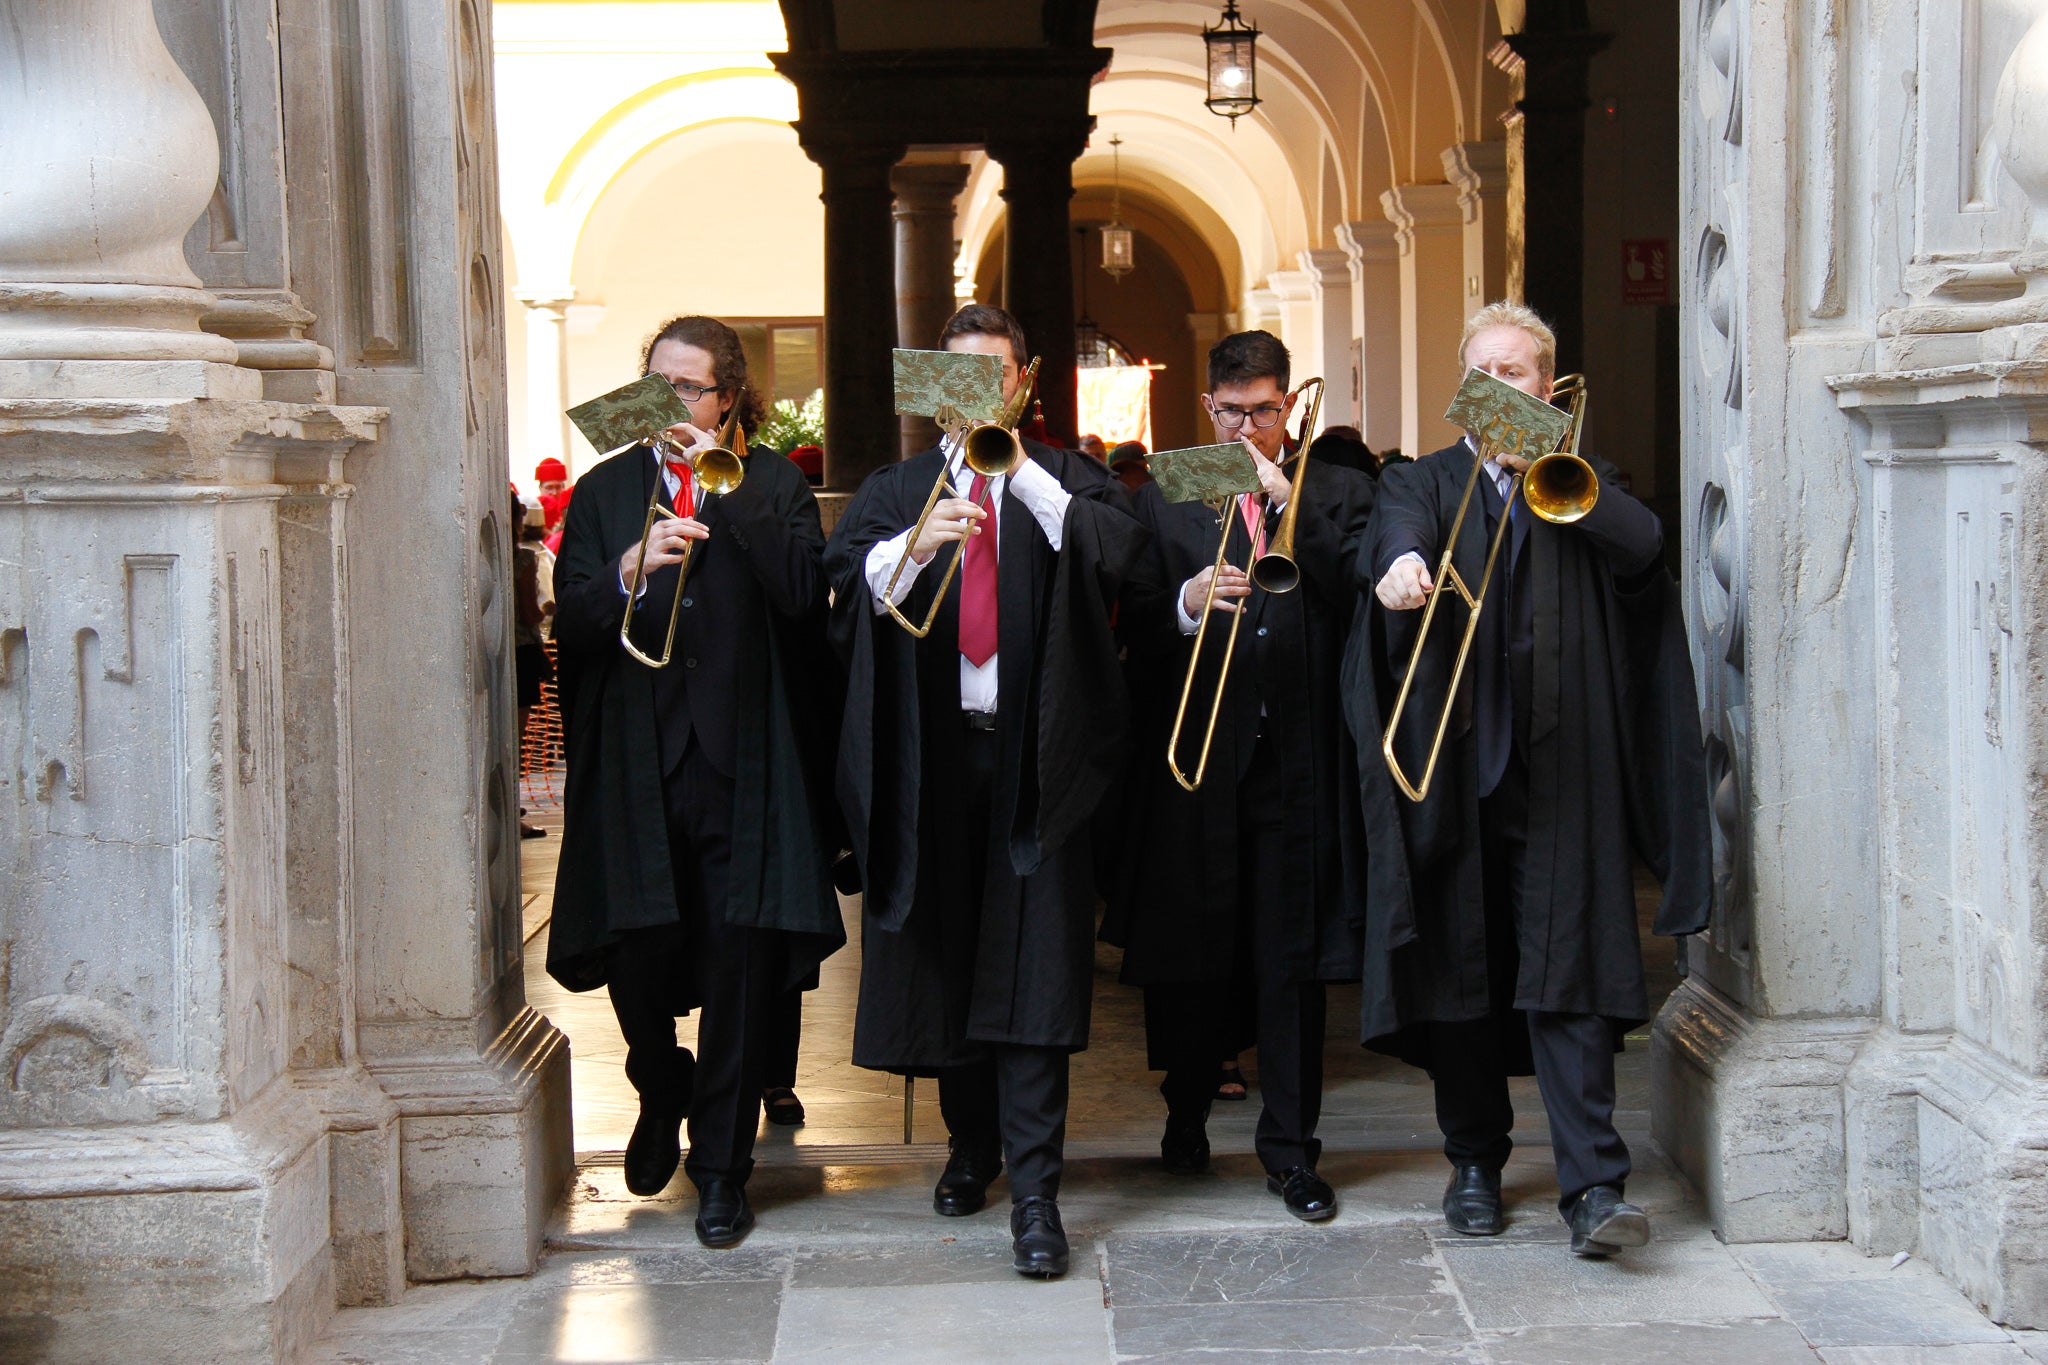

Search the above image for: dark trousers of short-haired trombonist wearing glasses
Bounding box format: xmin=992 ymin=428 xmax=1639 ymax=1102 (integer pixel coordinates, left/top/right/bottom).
xmin=1145 ymin=739 xmax=1325 ymax=1173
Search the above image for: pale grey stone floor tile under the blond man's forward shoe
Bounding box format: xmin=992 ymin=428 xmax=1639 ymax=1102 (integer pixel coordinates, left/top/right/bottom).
xmin=1438 ymin=1238 xmax=1778 ymax=1330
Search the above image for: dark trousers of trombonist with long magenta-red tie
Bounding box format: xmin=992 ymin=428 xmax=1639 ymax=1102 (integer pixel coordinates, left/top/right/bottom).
xmin=938 ymin=729 xmax=1067 ymax=1201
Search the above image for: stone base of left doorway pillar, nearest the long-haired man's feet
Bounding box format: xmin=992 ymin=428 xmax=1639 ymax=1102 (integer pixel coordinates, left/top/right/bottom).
xmin=369 ymin=1009 xmax=575 ymax=1281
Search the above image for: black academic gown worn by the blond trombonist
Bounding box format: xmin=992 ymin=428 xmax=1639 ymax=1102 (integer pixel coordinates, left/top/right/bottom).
xmin=1343 ymin=442 xmax=1712 ymax=1072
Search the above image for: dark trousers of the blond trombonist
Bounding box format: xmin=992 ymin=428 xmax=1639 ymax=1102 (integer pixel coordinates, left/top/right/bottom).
xmin=1427 ymin=757 xmax=1630 ymax=1216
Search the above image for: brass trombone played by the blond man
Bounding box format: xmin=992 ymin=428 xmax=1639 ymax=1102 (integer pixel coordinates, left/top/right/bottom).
xmin=1380 ymin=375 xmax=1599 ymax=800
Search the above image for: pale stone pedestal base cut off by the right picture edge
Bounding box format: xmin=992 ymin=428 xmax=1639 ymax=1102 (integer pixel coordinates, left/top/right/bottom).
xmin=1843 ymin=1029 xmax=2048 ymax=1328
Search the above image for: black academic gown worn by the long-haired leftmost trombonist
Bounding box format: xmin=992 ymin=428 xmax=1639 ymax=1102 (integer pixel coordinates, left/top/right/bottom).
xmin=547 ymin=446 xmax=846 ymax=1009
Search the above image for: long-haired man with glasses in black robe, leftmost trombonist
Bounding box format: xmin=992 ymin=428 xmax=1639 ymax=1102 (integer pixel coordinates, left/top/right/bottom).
xmin=547 ymin=317 xmax=846 ymax=1246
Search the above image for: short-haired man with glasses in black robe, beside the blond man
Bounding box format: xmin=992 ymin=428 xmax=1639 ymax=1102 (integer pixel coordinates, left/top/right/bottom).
xmin=1104 ymin=332 xmax=1372 ymax=1222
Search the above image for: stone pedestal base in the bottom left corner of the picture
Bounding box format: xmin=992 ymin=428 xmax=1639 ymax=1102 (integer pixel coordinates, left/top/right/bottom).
xmin=0 ymin=1078 xmax=334 ymax=1365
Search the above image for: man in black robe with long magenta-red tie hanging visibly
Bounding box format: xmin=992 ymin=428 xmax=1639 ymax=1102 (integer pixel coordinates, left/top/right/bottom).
xmin=825 ymin=305 xmax=1145 ymax=1275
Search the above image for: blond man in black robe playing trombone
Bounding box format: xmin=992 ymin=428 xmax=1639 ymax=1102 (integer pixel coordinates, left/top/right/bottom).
xmin=1343 ymin=305 xmax=1710 ymax=1257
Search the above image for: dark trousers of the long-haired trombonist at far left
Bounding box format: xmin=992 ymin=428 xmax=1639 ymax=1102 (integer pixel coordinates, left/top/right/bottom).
xmin=608 ymin=741 xmax=784 ymax=1185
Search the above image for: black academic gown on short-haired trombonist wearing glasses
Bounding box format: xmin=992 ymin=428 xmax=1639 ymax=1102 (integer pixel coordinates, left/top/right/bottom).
xmin=1102 ymin=460 xmax=1374 ymax=986
